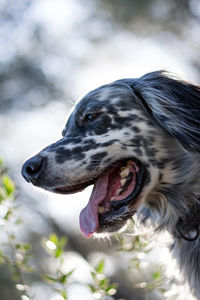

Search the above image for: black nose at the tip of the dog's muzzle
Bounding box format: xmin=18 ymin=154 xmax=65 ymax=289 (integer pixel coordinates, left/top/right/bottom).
xmin=22 ymin=155 xmax=44 ymax=182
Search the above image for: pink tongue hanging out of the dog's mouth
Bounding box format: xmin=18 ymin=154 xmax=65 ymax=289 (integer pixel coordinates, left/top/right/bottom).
xmin=79 ymin=173 xmax=108 ymax=238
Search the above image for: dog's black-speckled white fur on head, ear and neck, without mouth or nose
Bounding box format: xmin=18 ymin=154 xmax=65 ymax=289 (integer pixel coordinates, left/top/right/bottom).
xmin=21 ymin=71 xmax=200 ymax=299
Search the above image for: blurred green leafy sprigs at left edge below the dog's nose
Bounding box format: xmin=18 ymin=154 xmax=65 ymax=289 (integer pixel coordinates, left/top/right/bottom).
xmin=0 ymin=159 xmax=33 ymax=300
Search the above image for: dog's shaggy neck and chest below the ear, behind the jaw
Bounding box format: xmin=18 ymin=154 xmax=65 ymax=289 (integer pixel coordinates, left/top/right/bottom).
xmin=139 ymin=153 xmax=200 ymax=300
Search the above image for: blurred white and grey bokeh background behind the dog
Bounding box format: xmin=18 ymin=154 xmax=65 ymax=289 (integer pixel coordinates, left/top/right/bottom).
xmin=0 ymin=0 xmax=200 ymax=300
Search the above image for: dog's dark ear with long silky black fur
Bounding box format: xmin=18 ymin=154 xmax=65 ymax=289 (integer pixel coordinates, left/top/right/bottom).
xmin=129 ymin=71 xmax=200 ymax=152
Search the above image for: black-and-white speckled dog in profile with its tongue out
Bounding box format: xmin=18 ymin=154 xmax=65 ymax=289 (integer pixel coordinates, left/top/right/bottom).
xmin=22 ymin=71 xmax=200 ymax=299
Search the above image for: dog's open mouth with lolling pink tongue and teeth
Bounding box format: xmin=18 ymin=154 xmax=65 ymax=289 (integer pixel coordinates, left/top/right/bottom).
xmin=54 ymin=158 xmax=147 ymax=238
